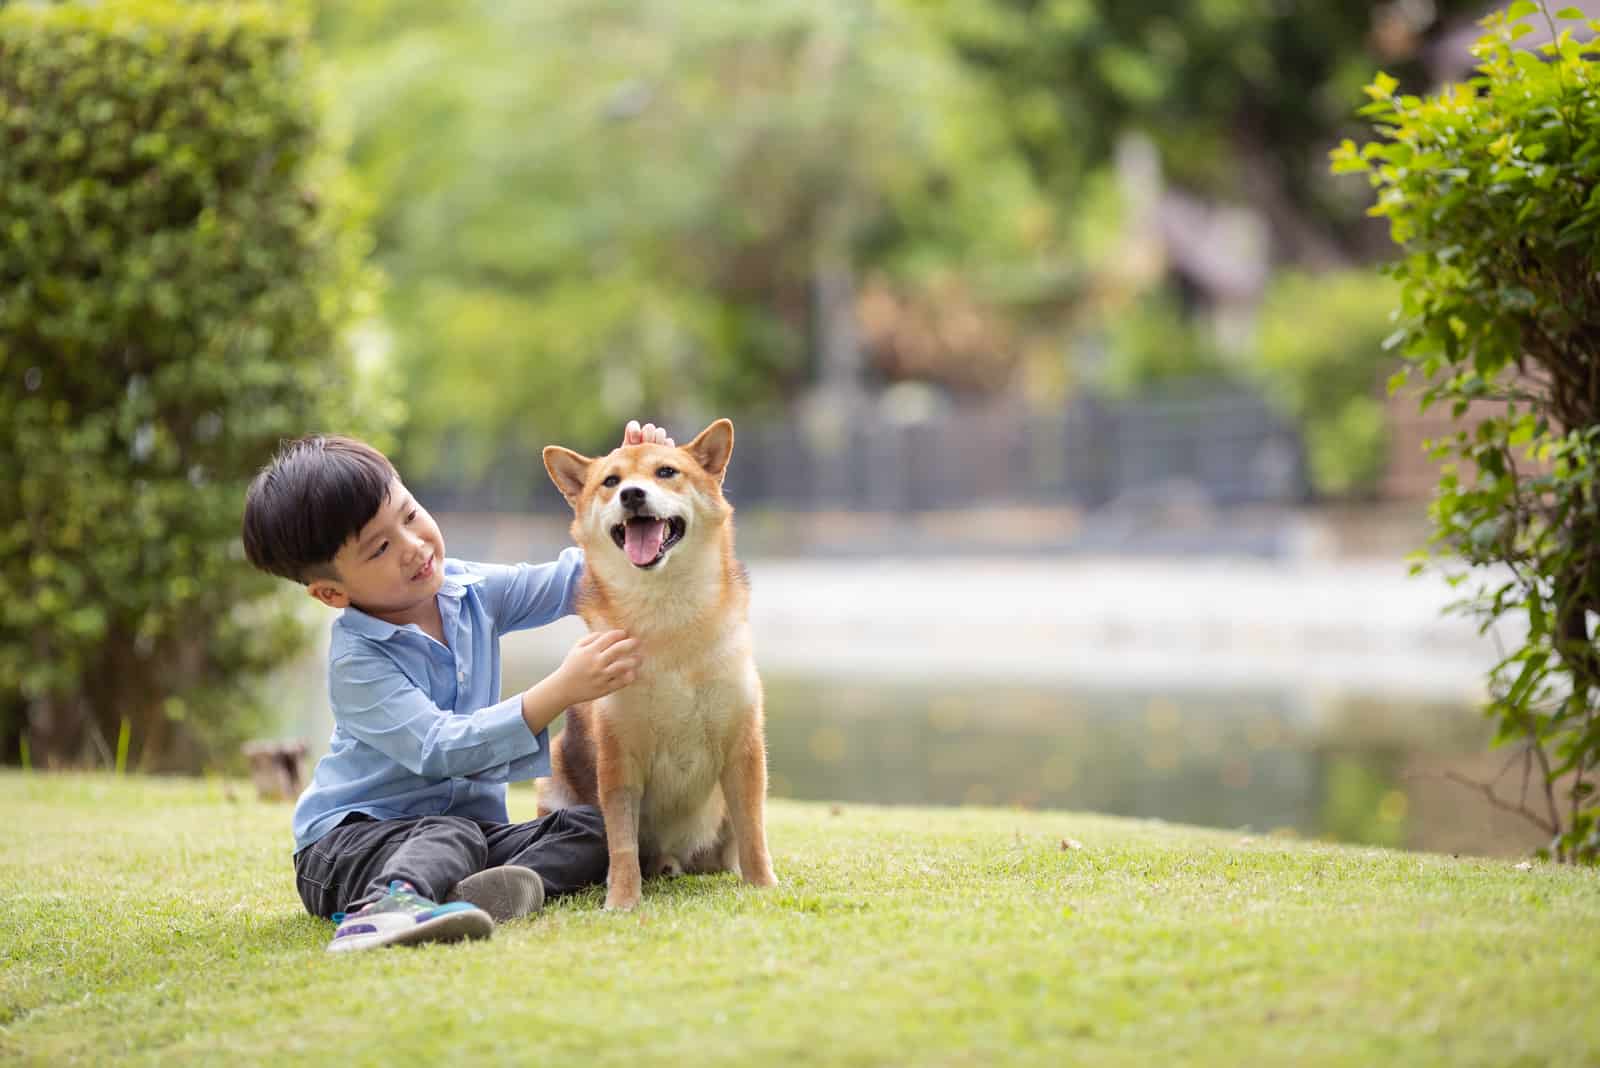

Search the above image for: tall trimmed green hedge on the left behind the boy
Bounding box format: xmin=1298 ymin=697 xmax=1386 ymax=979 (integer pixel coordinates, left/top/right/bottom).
xmin=0 ymin=2 xmax=387 ymax=767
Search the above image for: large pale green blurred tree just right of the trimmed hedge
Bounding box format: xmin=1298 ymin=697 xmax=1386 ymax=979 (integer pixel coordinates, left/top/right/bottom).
xmin=318 ymin=0 xmax=1062 ymax=470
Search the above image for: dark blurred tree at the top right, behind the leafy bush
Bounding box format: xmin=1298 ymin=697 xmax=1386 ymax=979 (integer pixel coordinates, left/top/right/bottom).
xmin=909 ymin=0 xmax=1483 ymax=267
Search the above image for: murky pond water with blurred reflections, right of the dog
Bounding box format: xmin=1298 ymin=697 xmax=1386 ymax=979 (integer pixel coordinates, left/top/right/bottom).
xmin=766 ymin=678 xmax=1534 ymax=852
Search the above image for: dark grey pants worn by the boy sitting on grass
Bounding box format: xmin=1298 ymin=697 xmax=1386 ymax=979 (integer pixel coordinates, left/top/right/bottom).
xmin=294 ymin=806 xmax=608 ymax=916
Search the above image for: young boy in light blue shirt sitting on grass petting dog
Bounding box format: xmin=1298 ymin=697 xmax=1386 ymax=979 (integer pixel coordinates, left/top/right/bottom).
xmin=243 ymin=422 xmax=672 ymax=951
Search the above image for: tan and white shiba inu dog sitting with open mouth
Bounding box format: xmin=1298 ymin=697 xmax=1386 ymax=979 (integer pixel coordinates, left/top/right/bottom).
xmin=539 ymin=419 xmax=776 ymax=908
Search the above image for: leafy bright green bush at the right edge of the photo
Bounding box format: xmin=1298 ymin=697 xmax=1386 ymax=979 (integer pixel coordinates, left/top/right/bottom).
xmin=1334 ymin=0 xmax=1600 ymax=862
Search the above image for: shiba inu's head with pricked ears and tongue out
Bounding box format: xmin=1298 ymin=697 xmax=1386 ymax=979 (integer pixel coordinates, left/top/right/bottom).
xmin=544 ymin=419 xmax=733 ymax=571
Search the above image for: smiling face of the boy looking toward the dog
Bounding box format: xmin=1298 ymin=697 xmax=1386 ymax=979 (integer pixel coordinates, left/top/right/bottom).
xmin=307 ymin=478 xmax=445 ymax=622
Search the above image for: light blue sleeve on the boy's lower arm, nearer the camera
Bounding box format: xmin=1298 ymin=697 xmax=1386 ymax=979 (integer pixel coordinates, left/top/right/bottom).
xmin=328 ymin=652 xmax=550 ymax=782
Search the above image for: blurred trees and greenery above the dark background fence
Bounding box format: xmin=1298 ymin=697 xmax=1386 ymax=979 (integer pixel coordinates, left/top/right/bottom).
xmin=315 ymin=0 xmax=1478 ymax=482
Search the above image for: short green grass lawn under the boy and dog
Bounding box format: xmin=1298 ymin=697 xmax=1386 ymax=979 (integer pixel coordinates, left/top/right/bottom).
xmin=0 ymin=774 xmax=1600 ymax=1068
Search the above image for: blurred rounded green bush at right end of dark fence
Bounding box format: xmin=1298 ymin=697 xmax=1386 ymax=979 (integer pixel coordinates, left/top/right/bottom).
xmin=1254 ymin=272 xmax=1398 ymax=496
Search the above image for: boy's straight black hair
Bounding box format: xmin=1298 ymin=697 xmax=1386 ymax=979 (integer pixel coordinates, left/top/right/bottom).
xmin=243 ymin=433 xmax=395 ymax=584
